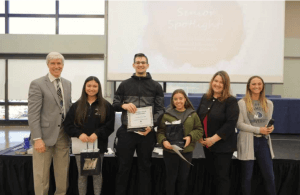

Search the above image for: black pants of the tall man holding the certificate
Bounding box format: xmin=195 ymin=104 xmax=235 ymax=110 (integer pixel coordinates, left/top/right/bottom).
xmin=115 ymin=126 xmax=156 ymax=195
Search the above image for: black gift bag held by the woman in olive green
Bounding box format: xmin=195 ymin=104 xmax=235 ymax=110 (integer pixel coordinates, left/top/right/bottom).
xmin=166 ymin=123 xmax=185 ymax=148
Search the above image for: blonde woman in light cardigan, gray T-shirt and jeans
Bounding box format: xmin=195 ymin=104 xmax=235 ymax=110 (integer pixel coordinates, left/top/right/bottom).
xmin=237 ymin=76 xmax=276 ymax=195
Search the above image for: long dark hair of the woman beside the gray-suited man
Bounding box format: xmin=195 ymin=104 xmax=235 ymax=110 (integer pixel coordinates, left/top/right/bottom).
xmin=75 ymin=76 xmax=106 ymax=125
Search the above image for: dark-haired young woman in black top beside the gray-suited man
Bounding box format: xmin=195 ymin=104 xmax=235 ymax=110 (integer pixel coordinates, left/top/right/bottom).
xmin=64 ymin=76 xmax=115 ymax=195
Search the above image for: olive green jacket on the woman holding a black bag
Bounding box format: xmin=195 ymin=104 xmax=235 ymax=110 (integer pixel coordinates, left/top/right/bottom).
xmin=157 ymin=108 xmax=203 ymax=153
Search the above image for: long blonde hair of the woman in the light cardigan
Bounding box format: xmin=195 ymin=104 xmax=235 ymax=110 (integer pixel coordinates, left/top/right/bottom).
xmin=243 ymin=76 xmax=268 ymax=113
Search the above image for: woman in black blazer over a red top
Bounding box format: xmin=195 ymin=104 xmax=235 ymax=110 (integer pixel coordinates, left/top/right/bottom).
xmin=197 ymin=71 xmax=239 ymax=195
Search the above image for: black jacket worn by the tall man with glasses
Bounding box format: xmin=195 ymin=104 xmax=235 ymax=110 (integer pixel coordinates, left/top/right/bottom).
xmin=113 ymin=73 xmax=164 ymax=126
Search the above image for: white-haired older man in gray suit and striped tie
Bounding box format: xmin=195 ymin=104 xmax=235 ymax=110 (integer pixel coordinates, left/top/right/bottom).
xmin=28 ymin=52 xmax=72 ymax=195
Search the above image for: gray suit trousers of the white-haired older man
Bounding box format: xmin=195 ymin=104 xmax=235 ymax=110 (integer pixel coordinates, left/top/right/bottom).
xmin=32 ymin=129 xmax=70 ymax=195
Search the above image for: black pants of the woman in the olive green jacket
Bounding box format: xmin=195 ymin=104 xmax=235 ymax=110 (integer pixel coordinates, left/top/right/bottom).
xmin=164 ymin=151 xmax=193 ymax=195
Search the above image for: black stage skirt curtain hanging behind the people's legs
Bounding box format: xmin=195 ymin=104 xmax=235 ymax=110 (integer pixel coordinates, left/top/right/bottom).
xmin=0 ymin=155 xmax=300 ymax=195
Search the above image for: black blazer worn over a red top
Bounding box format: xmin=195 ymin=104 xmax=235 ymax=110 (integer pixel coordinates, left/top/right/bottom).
xmin=197 ymin=94 xmax=239 ymax=153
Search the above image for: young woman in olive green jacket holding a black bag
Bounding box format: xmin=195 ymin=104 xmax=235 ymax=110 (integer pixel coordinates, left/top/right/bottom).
xmin=157 ymin=89 xmax=203 ymax=195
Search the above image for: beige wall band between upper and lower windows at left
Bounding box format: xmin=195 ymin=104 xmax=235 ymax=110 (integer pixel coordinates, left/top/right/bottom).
xmin=0 ymin=34 xmax=106 ymax=54
